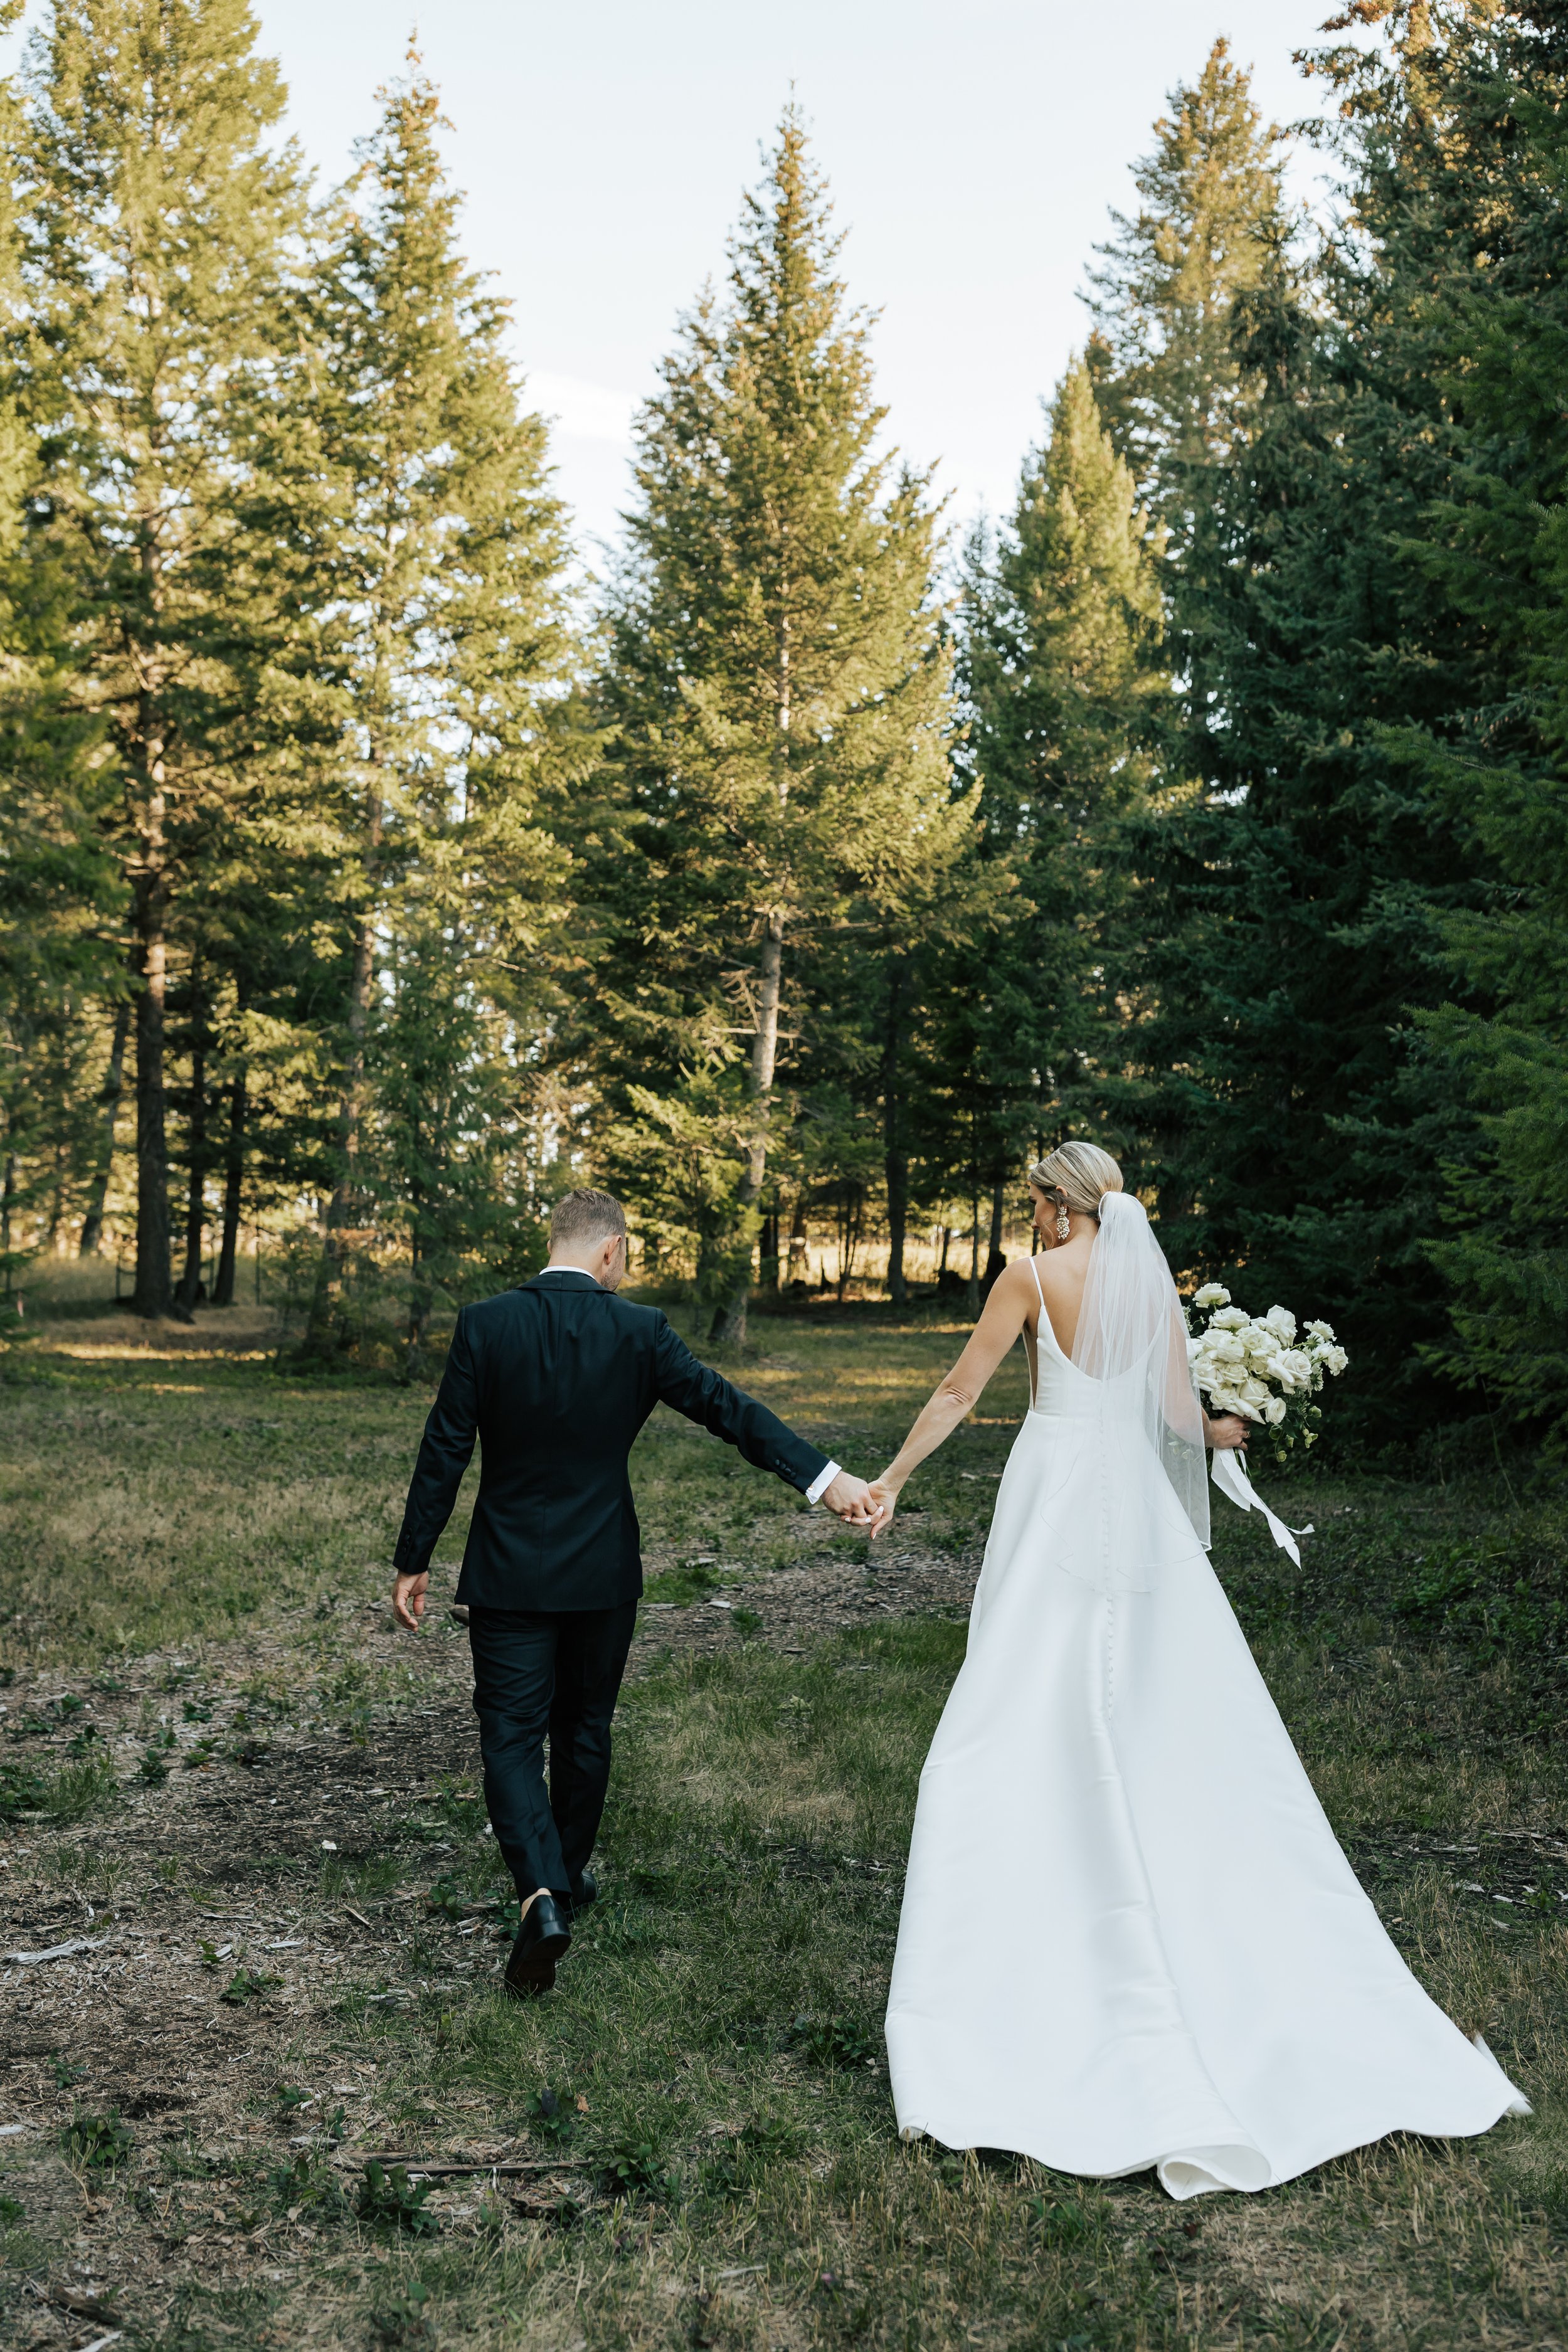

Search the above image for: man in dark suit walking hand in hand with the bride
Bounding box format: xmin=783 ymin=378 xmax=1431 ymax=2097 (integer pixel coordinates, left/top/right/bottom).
xmin=393 ymin=1192 xmax=877 ymax=1997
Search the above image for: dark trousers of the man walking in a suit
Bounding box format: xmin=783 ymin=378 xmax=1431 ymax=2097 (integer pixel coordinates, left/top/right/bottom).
xmin=468 ymin=1602 xmax=637 ymax=1900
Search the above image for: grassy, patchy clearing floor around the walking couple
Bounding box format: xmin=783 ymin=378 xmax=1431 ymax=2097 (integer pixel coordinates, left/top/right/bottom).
xmin=0 ymin=1301 xmax=1568 ymax=2352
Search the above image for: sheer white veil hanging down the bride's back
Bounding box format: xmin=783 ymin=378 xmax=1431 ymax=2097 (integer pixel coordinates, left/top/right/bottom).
xmin=1062 ymin=1192 xmax=1209 ymax=1590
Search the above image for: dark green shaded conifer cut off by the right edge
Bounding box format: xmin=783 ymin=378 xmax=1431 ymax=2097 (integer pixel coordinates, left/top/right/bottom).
xmin=1326 ymin=7 xmax=1568 ymax=1463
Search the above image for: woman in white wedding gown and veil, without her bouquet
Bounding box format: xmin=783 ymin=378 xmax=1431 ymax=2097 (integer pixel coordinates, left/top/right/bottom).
xmin=872 ymin=1143 xmax=1528 ymax=2197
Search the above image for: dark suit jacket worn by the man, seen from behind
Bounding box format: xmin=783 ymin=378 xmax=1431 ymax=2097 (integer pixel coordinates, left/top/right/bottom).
xmin=393 ymin=1275 xmax=827 ymax=1609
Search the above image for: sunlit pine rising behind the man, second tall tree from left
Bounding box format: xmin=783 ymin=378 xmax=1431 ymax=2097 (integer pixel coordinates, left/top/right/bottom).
xmin=310 ymin=52 xmax=571 ymax=1355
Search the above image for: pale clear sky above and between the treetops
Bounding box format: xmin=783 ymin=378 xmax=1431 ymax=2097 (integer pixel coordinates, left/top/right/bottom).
xmin=51 ymin=0 xmax=1353 ymax=555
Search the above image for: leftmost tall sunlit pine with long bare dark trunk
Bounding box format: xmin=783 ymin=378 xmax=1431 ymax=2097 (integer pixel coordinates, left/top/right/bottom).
xmin=23 ymin=0 xmax=301 ymax=1315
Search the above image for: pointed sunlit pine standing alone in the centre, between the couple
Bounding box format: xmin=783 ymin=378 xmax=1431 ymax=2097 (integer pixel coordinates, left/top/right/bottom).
xmin=597 ymin=110 xmax=971 ymax=1338
